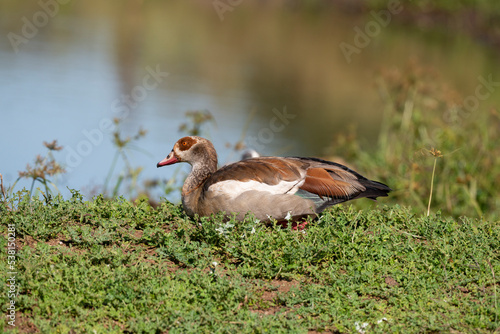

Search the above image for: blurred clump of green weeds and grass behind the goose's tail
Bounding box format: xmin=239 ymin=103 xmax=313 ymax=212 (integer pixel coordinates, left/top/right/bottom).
xmin=327 ymin=62 xmax=500 ymax=220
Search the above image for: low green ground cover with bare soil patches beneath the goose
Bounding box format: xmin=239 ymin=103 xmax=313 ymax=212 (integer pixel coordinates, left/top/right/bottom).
xmin=0 ymin=192 xmax=500 ymax=333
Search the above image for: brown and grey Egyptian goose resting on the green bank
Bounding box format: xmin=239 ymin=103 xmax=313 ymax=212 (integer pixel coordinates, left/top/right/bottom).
xmin=157 ymin=136 xmax=391 ymax=221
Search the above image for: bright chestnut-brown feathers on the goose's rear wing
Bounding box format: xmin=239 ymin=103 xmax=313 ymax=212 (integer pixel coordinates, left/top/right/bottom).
xmin=300 ymin=168 xmax=365 ymax=199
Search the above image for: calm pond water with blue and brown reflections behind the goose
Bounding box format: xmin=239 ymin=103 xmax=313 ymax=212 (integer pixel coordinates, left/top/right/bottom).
xmin=0 ymin=0 xmax=500 ymax=201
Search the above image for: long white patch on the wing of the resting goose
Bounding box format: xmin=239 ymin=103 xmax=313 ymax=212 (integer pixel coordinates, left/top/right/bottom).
xmin=208 ymin=180 xmax=305 ymax=198
